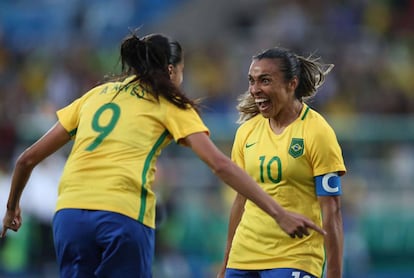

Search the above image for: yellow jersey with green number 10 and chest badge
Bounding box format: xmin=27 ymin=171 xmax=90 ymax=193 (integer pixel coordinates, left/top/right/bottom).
xmin=227 ymin=105 xmax=346 ymax=277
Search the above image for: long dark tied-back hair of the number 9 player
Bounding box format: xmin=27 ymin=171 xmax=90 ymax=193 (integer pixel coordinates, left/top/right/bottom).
xmin=114 ymin=29 xmax=197 ymax=109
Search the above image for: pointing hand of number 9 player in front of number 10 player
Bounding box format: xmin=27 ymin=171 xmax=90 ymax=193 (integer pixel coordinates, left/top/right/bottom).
xmin=277 ymin=211 xmax=326 ymax=238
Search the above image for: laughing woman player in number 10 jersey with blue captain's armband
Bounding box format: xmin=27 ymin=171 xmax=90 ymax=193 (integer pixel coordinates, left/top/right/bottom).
xmin=218 ymin=48 xmax=346 ymax=278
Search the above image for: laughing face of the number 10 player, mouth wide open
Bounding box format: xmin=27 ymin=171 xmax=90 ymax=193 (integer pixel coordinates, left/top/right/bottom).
xmin=248 ymin=58 xmax=298 ymax=119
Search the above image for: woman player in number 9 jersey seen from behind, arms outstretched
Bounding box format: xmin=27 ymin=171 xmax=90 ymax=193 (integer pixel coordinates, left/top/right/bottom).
xmin=1 ymin=31 xmax=324 ymax=278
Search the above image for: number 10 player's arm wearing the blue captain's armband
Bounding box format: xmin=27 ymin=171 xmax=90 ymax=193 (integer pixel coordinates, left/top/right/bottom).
xmin=315 ymin=173 xmax=343 ymax=278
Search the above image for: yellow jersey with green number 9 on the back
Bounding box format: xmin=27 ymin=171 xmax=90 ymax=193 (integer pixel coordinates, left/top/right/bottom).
xmin=56 ymin=78 xmax=209 ymax=228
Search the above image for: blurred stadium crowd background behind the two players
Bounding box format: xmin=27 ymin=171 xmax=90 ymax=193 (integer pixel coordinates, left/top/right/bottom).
xmin=0 ymin=0 xmax=414 ymax=278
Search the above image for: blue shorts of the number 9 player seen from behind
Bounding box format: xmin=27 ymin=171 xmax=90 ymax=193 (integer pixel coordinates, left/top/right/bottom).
xmin=53 ymin=209 xmax=155 ymax=278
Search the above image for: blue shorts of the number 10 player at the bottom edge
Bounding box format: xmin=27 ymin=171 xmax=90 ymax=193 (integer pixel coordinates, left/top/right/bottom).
xmin=225 ymin=268 xmax=316 ymax=278
